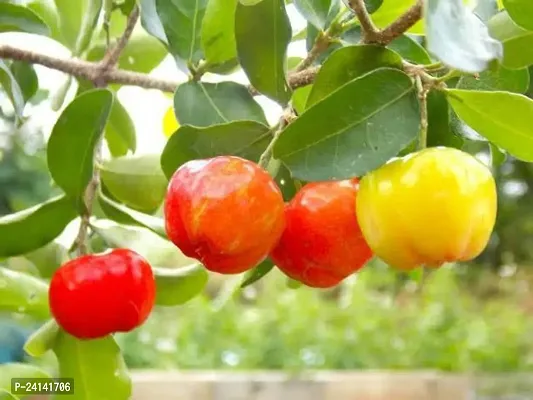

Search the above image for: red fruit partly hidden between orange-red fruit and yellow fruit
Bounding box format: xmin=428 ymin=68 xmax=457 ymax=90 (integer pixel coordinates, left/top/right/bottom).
xmin=270 ymin=179 xmax=372 ymax=288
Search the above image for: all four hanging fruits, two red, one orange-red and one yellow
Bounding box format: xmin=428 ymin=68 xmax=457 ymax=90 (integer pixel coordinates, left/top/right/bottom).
xmin=50 ymin=147 xmax=497 ymax=338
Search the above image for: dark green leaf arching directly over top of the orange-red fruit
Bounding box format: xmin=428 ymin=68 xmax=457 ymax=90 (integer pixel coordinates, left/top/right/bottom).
xmin=161 ymin=121 xmax=272 ymax=179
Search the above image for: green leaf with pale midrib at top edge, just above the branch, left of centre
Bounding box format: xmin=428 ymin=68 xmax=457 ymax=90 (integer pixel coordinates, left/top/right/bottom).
xmin=155 ymin=0 xmax=207 ymax=63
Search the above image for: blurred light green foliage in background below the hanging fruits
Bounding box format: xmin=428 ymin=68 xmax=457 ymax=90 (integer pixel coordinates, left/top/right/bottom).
xmin=118 ymin=262 xmax=533 ymax=372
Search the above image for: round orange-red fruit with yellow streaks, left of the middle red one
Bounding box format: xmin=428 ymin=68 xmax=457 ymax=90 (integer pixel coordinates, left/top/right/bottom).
xmin=165 ymin=156 xmax=285 ymax=274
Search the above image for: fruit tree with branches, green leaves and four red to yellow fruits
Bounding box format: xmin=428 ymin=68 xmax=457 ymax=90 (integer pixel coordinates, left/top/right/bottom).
xmin=0 ymin=0 xmax=533 ymax=400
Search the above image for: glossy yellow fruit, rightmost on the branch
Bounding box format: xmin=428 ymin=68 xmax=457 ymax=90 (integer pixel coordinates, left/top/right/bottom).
xmin=356 ymin=147 xmax=497 ymax=270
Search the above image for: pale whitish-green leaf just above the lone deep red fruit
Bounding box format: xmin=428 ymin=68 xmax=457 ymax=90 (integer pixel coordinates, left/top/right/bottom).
xmin=92 ymin=219 xmax=197 ymax=268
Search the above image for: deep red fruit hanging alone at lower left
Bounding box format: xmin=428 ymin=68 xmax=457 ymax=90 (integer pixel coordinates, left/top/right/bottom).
xmin=48 ymin=249 xmax=156 ymax=339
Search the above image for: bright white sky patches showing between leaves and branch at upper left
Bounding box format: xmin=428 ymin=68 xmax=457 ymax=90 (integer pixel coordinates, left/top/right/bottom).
xmin=0 ymin=4 xmax=306 ymax=158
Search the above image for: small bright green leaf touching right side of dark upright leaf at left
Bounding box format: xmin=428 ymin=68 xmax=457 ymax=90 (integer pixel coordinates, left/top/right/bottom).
xmin=105 ymin=95 xmax=137 ymax=157
